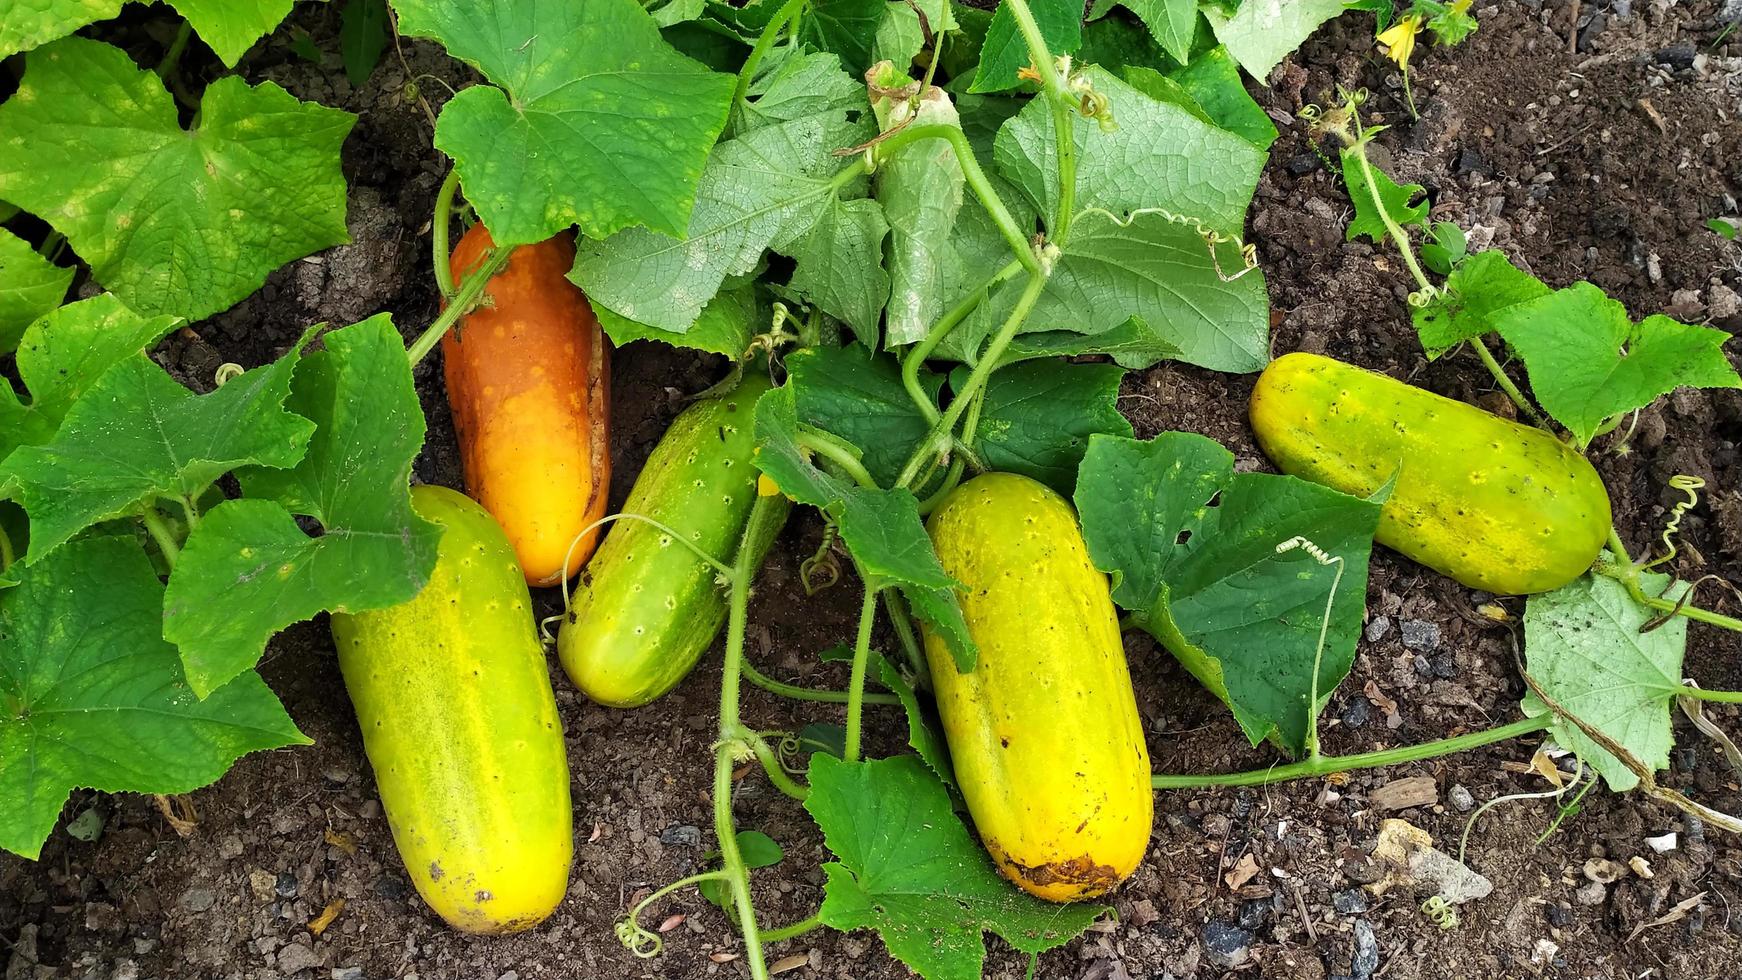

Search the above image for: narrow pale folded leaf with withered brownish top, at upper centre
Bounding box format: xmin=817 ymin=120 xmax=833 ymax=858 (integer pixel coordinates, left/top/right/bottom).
xmin=861 ymin=75 xmax=968 ymax=346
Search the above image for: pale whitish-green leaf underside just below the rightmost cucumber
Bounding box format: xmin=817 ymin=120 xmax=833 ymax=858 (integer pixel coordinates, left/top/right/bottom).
xmin=1523 ymin=573 xmax=1688 ymax=792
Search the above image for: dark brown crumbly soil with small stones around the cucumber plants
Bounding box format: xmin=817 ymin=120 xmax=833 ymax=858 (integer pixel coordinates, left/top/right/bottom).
xmin=0 ymin=0 xmax=1742 ymax=980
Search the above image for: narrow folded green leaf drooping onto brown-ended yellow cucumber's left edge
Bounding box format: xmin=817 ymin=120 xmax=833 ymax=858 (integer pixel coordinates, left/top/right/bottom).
xmin=756 ymin=385 xmax=977 ymax=670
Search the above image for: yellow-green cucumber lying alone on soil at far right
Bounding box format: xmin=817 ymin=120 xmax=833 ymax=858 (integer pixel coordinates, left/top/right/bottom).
xmin=1251 ymin=353 xmax=1610 ymax=595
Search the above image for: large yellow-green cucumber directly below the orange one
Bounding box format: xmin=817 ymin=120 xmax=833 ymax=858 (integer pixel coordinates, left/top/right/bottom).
xmin=333 ymin=486 xmax=575 ymax=933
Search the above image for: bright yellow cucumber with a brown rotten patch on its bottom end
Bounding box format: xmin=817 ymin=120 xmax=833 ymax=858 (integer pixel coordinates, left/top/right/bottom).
xmin=925 ymin=473 xmax=1155 ymax=902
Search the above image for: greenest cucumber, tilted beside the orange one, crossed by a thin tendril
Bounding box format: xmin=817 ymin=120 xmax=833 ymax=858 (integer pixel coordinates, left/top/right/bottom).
xmin=556 ymin=373 xmax=784 ymax=708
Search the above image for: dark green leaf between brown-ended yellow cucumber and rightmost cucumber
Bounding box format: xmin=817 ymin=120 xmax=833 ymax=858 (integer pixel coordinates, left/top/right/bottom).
xmin=1075 ymin=432 xmax=1388 ymax=752
